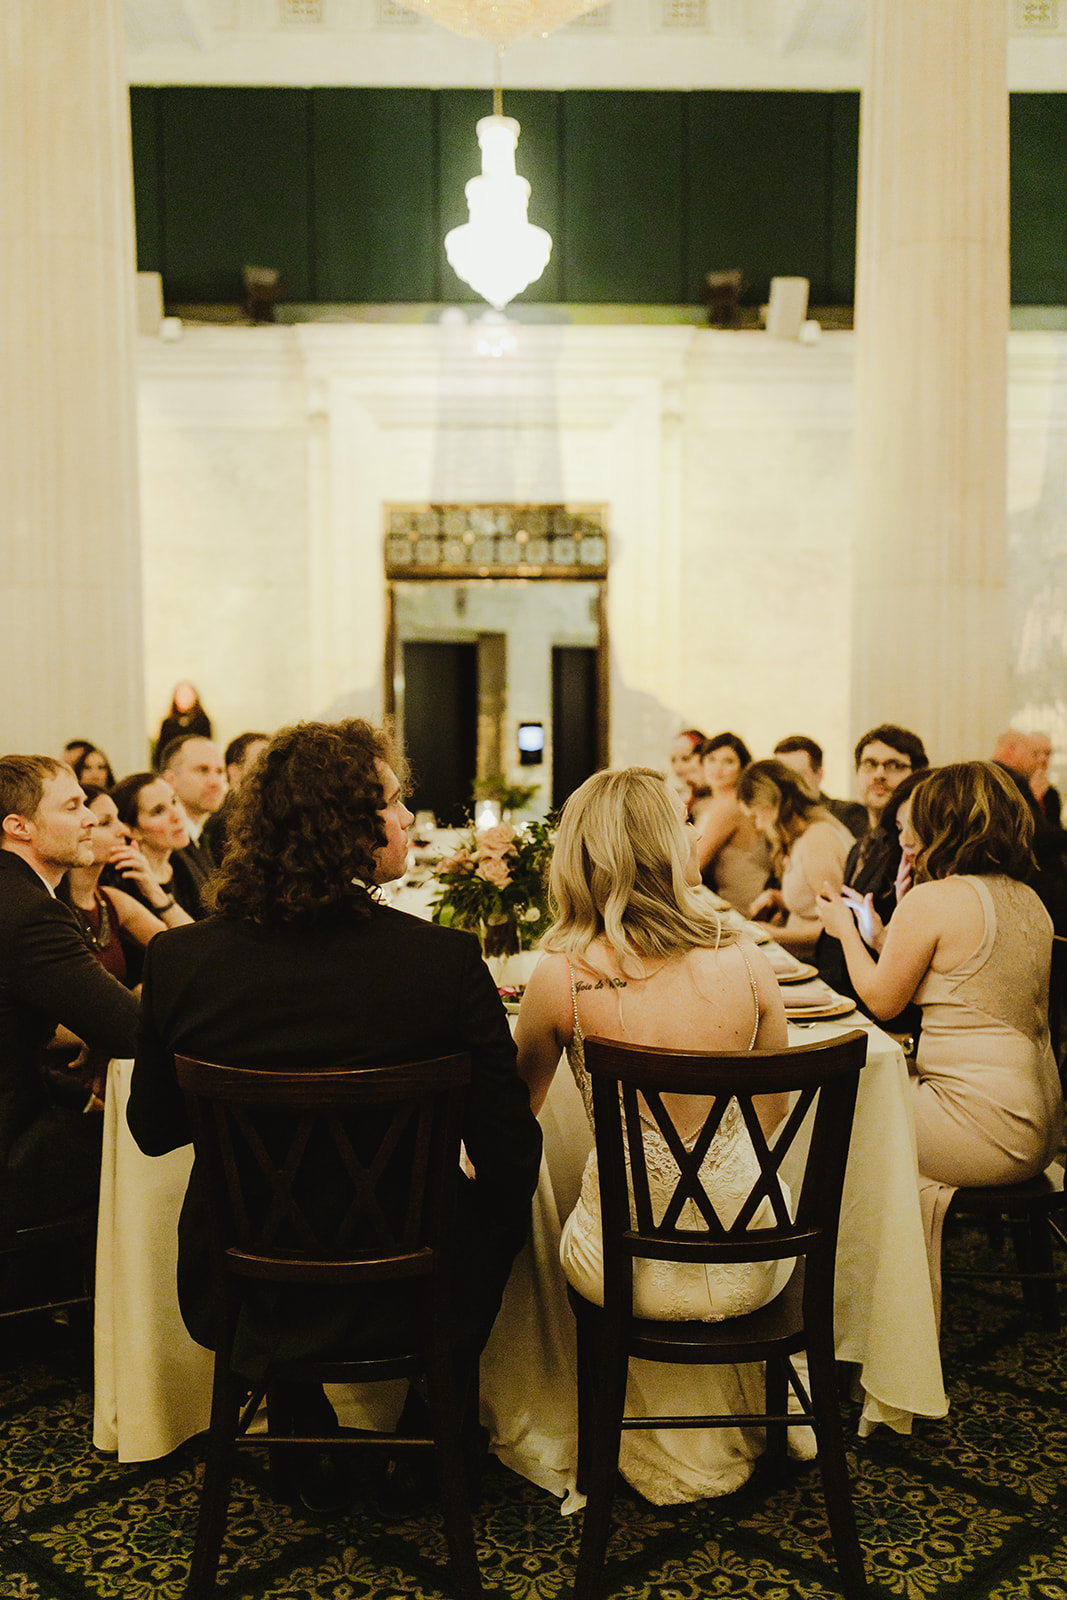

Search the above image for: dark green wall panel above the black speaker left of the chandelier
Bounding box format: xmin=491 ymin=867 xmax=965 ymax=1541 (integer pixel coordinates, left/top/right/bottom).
xmin=158 ymin=88 xmax=317 ymax=302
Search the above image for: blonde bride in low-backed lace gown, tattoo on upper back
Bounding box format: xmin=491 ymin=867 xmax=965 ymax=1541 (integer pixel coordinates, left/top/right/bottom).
xmin=515 ymin=766 xmax=789 ymax=1506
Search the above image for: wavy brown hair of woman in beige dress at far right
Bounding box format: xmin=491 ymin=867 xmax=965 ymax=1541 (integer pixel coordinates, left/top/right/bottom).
xmin=912 ymin=762 xmax=1035 ymax=883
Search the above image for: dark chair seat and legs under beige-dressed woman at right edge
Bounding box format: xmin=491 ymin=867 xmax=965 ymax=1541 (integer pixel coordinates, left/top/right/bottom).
xmin=941 ymin=1166 xmax=1067 ymax=1333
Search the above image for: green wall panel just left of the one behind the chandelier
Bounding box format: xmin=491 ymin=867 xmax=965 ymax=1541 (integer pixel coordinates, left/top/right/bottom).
xmin=310 ymin=90 xmax=440 ymax=302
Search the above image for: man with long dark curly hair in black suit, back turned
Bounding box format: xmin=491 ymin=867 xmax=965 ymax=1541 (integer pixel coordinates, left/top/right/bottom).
xmin=128 ymin=718 xmax=541 ymax=1472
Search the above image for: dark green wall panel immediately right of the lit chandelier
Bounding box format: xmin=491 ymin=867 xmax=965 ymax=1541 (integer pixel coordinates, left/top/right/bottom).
xmin=561 ymin=90 xmax=688 ymax=306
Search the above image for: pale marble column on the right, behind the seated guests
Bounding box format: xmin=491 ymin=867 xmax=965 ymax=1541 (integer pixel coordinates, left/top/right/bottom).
xmin=853 ymin=0 xmax=1009 ymax=762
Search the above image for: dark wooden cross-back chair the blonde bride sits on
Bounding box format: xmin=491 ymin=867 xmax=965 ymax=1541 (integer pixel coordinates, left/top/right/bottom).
xmin=569 ymin=1030 xmax=867 ymax=1600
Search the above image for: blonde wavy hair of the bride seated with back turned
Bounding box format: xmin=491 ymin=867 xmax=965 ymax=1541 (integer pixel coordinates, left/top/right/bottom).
xmin=541 ymin=766 xmax=734 ymax=978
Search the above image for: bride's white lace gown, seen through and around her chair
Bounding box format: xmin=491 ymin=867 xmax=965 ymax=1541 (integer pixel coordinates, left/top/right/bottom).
xmin=560 ymin=952 xmax=790 ymax=1506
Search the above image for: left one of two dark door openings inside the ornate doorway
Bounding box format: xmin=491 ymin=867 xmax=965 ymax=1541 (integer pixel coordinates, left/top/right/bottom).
xmin=403 ymin=640 xmax=478 ymax=827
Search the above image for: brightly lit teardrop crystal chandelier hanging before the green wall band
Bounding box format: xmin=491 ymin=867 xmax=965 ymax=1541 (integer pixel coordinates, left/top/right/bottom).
xmin=445 ymin=110 xmax=552 ymax=310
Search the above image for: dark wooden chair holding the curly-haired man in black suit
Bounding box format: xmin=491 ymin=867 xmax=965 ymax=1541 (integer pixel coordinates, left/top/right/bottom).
xmin=176 ymin=1054 xmax=482 ymax=1600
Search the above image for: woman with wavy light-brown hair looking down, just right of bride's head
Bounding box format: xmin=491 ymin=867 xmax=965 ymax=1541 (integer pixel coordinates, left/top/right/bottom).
xmin=737 ymin=760 xmax=853 ymax=960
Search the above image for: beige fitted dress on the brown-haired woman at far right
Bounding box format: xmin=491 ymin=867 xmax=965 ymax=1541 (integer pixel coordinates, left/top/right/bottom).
xmin=912 ymin=877 xmax=1064 ymax=1307
